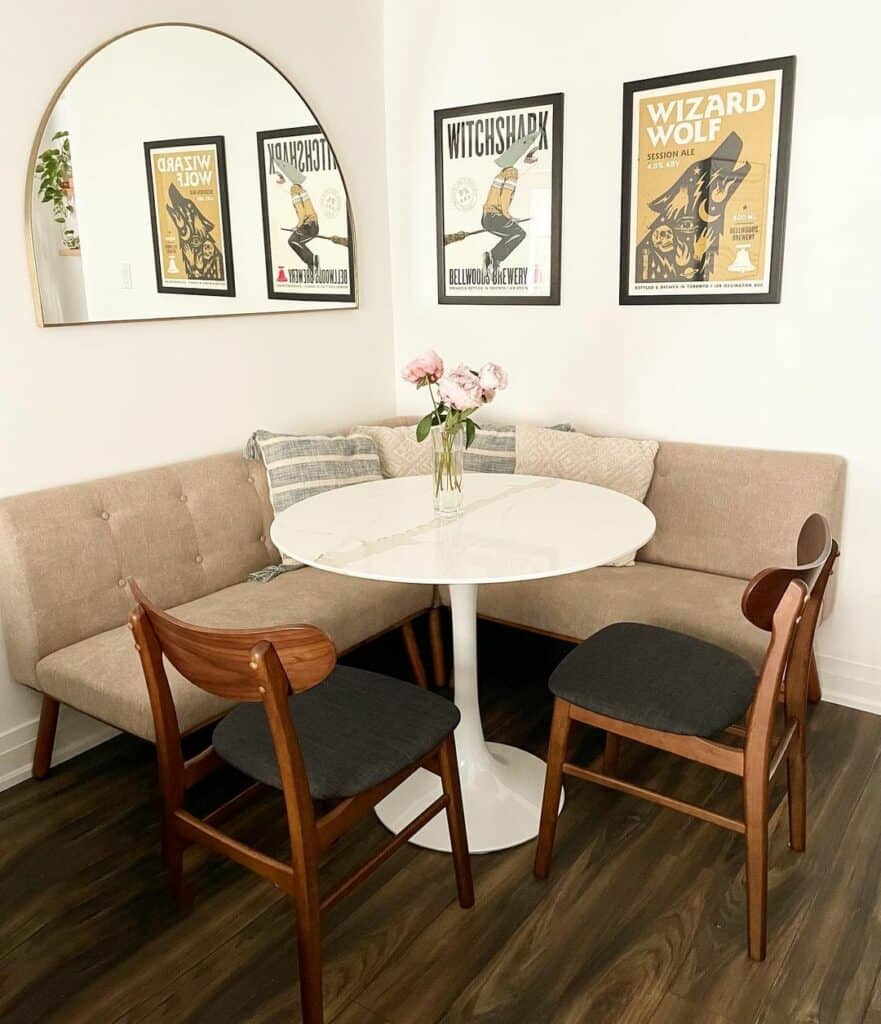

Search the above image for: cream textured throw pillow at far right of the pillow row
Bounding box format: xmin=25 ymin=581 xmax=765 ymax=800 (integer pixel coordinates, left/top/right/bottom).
xmin=516 ymin=426 xmax=658 ymax=565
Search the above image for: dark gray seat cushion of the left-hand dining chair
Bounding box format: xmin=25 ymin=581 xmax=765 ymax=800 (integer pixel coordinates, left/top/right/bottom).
xmin=214 ymin=665 xmax=459 ymax=800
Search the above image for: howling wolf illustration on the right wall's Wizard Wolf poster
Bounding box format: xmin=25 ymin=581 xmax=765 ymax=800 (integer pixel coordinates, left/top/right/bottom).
xmin=636 ymin=132 xmax=750 ymax=282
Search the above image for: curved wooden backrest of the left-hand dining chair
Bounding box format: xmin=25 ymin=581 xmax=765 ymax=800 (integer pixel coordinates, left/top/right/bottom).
xmin=129 ymin=581 xmax=336 ymax=700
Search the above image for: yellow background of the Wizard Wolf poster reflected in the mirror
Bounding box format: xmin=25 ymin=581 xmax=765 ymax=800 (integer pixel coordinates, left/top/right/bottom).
xmin=151 ymin=145 xmax=226 ymax=291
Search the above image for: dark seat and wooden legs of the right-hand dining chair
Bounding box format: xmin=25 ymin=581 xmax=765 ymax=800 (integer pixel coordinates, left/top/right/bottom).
xmin=535 ymin=573 xmax=808 ymax=961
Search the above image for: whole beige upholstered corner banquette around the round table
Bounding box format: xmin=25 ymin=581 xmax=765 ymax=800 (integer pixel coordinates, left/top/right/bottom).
xmin=0 ymin=423 xmax=844 ymax=775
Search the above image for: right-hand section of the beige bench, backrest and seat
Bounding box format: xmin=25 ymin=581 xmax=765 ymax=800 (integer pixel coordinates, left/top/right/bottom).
xmin=442 ymin=441 xmax=845 ymax=675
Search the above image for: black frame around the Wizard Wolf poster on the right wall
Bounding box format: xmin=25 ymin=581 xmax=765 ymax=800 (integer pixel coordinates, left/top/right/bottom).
xmin=619 ymin=56 xmax=796 ymax=305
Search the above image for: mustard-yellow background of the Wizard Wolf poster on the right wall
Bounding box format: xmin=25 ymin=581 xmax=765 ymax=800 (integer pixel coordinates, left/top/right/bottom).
xmin=631 ymin=76 xmax=778 ymax=291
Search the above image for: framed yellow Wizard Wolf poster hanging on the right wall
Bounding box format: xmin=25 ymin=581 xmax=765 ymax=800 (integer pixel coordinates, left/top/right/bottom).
xmin=620 ymin=57 xmax=795 ymax=305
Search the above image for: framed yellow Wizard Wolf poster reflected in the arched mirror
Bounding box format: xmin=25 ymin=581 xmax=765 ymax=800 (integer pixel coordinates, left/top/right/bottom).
xmin=143 ymin=135 xmax=236 ymax=296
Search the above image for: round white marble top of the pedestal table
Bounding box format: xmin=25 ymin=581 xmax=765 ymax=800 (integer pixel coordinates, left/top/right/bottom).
xmin=271 ymin=473 xmax=655 ymax=584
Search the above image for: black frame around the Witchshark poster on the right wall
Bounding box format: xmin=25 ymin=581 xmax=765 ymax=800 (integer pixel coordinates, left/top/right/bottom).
xmin=434 ymin=92 xmax=563 ymax=306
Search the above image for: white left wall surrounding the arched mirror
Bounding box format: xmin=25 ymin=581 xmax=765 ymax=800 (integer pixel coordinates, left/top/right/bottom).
xmin=0 ymin=0 xmax=393 ymax=784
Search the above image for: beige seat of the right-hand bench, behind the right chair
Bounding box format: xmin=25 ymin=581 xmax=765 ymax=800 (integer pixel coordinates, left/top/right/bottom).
xmin=444 ymin=562 xmax=769 ymax=669
